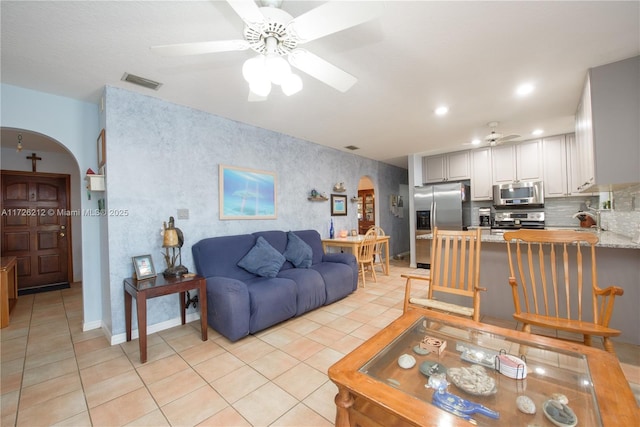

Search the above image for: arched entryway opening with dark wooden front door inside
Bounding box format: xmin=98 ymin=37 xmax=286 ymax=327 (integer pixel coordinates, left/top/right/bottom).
xmin=0 ymin=127 xmax=82 ymax=294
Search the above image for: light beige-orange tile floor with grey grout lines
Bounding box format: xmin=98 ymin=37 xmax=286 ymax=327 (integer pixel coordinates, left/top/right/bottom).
xmin=0 ymin=261 xmax=640 ymax=427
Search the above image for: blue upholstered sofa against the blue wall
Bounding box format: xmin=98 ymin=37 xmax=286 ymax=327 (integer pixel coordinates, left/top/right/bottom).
xmin=192 ymin=230 xmax=358 ymax=341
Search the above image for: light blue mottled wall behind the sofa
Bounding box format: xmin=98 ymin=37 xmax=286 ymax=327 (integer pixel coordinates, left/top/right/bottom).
xmin=105 ymin=87 xmax=409 ymax=335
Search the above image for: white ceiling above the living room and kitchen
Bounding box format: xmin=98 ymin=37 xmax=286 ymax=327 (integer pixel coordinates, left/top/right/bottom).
xmin=0 ymin=0 xmax=640 ymax=167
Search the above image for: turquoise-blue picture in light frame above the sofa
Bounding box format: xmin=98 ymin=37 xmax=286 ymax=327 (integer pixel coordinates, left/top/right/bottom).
xmin=218 ymin=165 xmax=277 ymax=219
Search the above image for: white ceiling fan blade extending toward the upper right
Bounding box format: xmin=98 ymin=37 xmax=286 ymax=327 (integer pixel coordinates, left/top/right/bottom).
xmin=289 ymin=1 xmax=384 ymax=43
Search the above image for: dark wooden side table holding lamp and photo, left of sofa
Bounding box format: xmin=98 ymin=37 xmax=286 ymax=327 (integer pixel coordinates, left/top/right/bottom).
xmin=124 ymin=275 xmax=207 ymax=363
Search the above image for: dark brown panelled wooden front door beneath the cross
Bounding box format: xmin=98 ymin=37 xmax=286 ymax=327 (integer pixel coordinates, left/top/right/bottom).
xmin=1 ymin=171 xmax=72 ymax=290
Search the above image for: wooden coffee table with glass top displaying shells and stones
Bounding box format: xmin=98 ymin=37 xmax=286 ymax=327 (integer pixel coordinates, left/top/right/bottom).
xmin=329 ymin=311 xmax=638 ymax=427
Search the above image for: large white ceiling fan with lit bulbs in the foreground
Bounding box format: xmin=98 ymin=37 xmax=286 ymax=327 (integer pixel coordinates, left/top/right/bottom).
xmin=151 ymin=0 xmax=383 ymax=101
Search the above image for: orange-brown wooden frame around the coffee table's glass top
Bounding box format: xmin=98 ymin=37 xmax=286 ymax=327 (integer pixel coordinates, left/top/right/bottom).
xmin=329 ymin=310 xmax=640 ymax=427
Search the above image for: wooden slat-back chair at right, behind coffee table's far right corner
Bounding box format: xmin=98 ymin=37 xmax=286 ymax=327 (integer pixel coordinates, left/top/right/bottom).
xmin=503 ymin=230 xmax=624 ymax=353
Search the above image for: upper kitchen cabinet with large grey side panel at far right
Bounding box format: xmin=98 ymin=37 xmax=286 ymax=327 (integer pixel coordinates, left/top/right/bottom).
xmin=576 ymin=56 xmax=640 ymax=193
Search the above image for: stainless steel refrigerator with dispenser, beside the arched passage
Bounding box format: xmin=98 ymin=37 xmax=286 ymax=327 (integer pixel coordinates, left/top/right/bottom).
xmin=414 ymin=182 xmax=471 ymax=268
